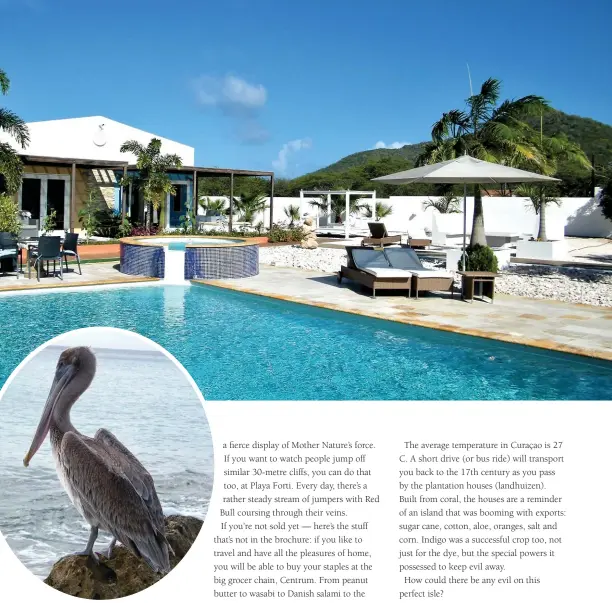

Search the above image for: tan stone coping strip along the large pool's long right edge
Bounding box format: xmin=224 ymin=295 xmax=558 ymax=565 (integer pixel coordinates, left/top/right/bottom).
xmin=192 ymin=279 xmax=612 ymax=361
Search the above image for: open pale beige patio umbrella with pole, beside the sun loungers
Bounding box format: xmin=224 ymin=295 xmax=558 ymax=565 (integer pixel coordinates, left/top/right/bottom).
xmin=372 ymin=155 xmax=559 ymax=270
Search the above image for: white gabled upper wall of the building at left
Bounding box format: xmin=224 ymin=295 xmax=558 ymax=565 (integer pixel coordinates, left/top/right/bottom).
xmin=0 ymin=116 xmax=195 ymax=166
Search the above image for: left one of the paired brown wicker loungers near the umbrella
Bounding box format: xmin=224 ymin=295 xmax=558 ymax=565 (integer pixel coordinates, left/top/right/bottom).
xmin=338 ymin=247 xmax=412 ymax=298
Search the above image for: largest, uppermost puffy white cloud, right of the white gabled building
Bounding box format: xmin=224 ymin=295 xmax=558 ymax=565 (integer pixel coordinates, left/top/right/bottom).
xmin=193 ymin=74 xmax=268 ymax=113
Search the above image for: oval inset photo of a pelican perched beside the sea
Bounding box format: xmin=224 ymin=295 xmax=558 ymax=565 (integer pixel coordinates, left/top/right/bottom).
xmin=0 ymin=327 xmax=214 ymax=599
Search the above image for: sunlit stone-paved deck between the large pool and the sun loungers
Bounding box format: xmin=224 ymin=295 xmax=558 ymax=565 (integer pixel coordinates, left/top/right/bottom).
xmin=198 ymin=265 xmax=612 ymax=360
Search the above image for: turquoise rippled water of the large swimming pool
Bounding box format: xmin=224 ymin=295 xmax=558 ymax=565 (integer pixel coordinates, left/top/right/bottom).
xmin=0 ymin=285 xmax=612 ymax=400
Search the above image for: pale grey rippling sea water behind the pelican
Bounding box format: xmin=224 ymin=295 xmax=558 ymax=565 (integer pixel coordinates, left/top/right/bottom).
xmin=0 ymin=346 xmax=213 ymax=578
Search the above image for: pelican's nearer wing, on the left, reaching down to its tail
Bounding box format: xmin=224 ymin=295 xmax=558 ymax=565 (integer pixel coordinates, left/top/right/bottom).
xmin=60 ymin=432 xmax=170 ymax=571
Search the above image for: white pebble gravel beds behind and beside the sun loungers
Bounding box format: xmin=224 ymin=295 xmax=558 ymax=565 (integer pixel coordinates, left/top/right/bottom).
xmin=259 ymin=246 xmax=612 ymax=307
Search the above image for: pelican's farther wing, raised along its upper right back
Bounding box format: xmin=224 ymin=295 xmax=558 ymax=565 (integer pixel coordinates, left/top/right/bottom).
xmin=94 ymin=429 xmax=164 ymax=528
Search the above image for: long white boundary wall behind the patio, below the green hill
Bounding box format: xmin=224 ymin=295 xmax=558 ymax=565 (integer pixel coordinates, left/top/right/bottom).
xmin=255 ymin=196 xmax=612 ymax=240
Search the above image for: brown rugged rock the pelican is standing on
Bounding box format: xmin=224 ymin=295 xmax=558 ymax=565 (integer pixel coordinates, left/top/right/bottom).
xmin=45 ymin=515 xmax=203 ymax=600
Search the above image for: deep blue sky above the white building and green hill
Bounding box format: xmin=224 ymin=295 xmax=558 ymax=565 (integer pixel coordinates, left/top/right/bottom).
xmin=0 ymin=0 xmax=612 ymax=176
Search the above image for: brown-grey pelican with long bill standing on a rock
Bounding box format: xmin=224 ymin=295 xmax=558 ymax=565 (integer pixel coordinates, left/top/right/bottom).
xmin=23 ymin=347 xmax=172 ymax=574
